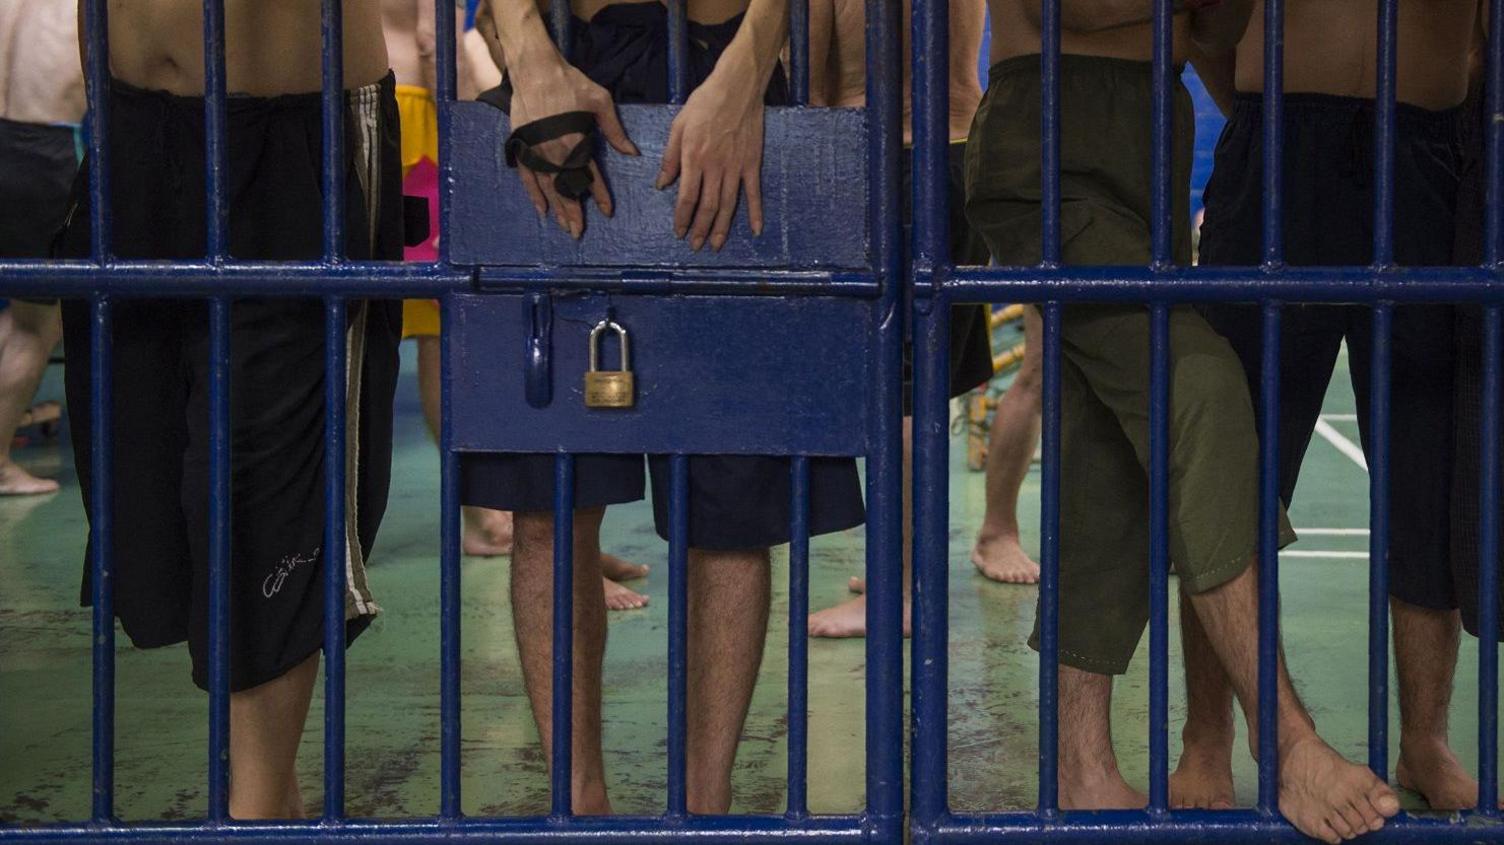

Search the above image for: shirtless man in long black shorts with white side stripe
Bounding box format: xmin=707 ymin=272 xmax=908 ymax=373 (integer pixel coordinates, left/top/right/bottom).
xmin=61 ymin=0 xmax=402 ymax=819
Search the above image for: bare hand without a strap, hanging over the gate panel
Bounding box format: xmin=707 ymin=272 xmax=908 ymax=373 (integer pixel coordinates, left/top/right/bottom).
xmin=656 ymin=63 xmax=763 ymax=251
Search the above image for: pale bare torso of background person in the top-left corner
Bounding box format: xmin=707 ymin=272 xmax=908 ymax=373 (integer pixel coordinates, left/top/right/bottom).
xmin=0 ymin=0 xmax=84 ymax=123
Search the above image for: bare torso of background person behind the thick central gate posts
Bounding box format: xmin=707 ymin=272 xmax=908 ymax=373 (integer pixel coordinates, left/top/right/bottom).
xmin=809 ymin=0 xmax=987 ymax=143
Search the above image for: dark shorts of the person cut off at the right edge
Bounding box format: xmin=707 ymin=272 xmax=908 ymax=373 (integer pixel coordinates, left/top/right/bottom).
xmin=1451 ymin=92 xmax=1504 ymax=631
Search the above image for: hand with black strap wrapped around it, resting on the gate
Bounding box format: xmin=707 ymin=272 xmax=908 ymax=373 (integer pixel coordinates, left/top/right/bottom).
xmin=511 ymin=53 xmax=641 ymax=238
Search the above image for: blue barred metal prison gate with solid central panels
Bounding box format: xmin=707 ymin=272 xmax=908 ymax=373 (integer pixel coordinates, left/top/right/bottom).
xmin=0 ymin=0 xmax=1504 ymax=843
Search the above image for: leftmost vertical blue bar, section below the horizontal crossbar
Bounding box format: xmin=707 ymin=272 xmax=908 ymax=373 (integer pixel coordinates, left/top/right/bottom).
xmin=89 ymin=296 xmax=114 ymax=824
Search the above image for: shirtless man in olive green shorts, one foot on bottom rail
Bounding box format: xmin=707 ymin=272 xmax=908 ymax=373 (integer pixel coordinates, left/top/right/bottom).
xmin=967 ymin=0 xmax=1399 ymax=842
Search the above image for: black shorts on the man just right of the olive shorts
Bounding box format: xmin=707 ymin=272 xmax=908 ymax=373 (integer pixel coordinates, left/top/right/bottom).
xmin=1200 ymin=95 xmax=1462 ymax=609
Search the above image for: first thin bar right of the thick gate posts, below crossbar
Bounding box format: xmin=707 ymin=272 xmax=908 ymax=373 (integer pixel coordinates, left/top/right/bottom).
xmin=1039 ymin=302 xmax=1062 ymax=818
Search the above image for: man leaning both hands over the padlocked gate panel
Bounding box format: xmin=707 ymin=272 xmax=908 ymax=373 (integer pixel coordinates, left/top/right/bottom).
xmin=475 ymin=0 xmax=863 ymax=813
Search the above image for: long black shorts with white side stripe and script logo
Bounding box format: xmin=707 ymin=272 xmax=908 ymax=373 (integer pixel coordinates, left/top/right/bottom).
xmin=59 ymin=77 xmax=402 ymax=690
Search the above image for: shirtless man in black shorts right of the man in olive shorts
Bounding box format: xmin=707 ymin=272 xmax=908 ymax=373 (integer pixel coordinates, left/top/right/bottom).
xmin=1173 ymin=0 xmax=1480 ymax=810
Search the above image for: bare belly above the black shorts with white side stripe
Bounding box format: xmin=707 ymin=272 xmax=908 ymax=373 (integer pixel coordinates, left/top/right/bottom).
xmin=104 ymin=0 xmax=388 ymax=96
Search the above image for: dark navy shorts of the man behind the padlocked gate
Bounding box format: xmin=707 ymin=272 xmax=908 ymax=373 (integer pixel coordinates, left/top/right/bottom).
xmin=460 ymin=3 xmax=865 ymax=550
